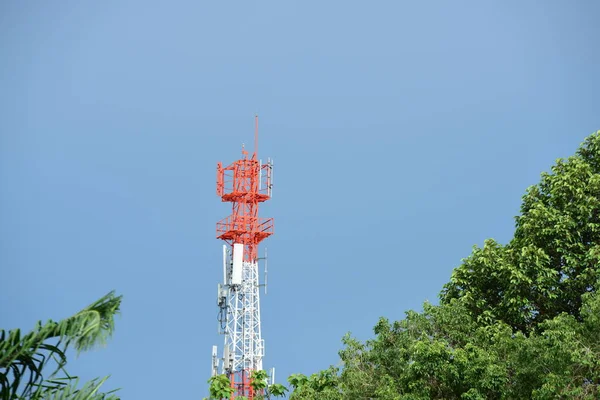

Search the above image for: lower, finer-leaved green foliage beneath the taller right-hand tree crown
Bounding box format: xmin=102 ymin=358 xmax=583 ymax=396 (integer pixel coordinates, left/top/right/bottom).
xmin=302 ymin=293 xmax=600 ymax=400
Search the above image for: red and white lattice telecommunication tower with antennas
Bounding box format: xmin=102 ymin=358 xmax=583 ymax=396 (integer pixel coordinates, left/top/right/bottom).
xmin=212 ymin=116 xmax=275 ymax=399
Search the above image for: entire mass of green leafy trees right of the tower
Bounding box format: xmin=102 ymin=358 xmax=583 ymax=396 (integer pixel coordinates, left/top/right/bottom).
xmin=288 ymin=131 xmax=600 ymax=400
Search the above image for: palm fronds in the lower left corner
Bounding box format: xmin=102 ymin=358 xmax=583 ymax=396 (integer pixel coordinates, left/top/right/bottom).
xmin=0 ymin=292 xmax=122 ymax=400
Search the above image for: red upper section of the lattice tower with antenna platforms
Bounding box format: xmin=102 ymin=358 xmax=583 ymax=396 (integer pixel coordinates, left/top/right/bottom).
xmin=217 ymin=116 xmax=273 ymax=262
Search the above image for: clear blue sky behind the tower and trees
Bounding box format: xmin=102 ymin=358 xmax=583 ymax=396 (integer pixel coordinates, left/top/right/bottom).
xmin=0 ymin=0 xmax=600 ymax=399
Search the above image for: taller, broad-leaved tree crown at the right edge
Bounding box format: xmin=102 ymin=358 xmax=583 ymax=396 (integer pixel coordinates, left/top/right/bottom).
xmin=441 ymin=131 xmax=600 ymax=332
